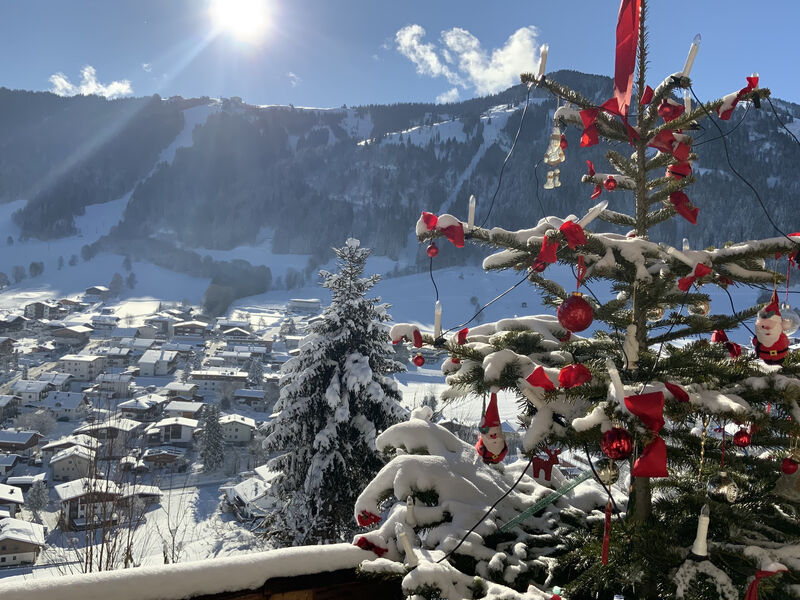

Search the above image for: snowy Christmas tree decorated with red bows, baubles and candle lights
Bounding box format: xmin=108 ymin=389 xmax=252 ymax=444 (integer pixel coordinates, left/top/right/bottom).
xmin=355 ymin=0 xmax=800 ymax=600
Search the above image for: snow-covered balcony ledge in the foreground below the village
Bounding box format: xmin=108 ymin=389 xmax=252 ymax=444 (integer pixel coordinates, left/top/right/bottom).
xmin=0 ymin=544 xmax=403 ymax=600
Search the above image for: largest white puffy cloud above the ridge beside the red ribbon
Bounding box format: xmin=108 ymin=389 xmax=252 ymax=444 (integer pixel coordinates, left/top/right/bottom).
xmin=395 ymin=25 xmax=539 ymax=101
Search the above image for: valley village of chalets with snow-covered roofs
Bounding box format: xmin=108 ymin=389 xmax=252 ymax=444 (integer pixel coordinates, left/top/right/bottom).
xmin=0 ymin=286 xmax=332 ymax=577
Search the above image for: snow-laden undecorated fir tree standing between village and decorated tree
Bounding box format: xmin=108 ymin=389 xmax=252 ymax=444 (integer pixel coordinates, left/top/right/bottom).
xmin=265 ymin=239 xmax=403 ymax=544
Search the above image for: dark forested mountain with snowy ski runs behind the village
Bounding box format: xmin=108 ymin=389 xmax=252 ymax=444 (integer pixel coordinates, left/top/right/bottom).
xmin=0 ymin=71 xmax=800 ymax=310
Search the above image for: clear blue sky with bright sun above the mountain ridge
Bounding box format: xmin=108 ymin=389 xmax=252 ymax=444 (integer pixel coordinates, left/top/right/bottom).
xmin=0 ymin=0 xmax=800 ymax=106
